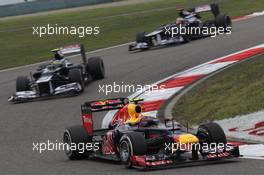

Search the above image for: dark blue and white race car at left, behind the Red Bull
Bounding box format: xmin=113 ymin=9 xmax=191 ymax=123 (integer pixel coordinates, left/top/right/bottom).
xmin=8 ymin=44 xmax=105 ymax=103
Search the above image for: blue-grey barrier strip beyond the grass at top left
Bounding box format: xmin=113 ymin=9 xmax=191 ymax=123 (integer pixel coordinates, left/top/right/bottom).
xmin=0 ymin=0 xmax=114 ymax=17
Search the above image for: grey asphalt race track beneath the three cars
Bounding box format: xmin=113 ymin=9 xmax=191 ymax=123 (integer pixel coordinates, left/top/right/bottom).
xmin=0 ymin=17 xmax=264 ymax=175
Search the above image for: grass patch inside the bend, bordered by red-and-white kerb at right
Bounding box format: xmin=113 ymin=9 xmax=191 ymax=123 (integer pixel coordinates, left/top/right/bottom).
xmin=173 ymin=54 xmax=264 ymax=124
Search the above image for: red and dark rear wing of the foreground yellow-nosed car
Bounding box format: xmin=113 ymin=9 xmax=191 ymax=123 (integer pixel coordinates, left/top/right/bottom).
xmin=81 ymin=98 xmax=143 ymax=135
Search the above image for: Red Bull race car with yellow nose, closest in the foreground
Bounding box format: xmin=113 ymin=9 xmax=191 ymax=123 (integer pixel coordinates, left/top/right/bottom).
xmin=63 ymin=98 xmax=240 ymax=170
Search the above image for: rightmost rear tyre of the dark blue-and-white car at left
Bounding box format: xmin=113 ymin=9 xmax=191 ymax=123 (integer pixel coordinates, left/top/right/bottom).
xmin=88 ymin=57 xmax=105 ymax=80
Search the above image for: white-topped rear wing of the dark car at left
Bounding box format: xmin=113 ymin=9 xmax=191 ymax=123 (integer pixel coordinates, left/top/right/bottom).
xmin=52 ymin=44 xmax=87 ymax=63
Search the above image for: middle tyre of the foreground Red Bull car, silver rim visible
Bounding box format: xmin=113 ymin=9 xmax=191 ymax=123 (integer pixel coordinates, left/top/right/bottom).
xmin=119 ymin=132 xmax=147 ymax=168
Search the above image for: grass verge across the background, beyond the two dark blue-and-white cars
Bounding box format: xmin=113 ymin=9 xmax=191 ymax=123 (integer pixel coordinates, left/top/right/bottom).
xmin=0 ymin=0 xmax=264 ymax=69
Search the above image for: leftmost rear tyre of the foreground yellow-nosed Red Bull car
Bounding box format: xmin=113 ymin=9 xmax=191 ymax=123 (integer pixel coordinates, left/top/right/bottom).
xmin=63 ymin=126 xmax=92 ymax=160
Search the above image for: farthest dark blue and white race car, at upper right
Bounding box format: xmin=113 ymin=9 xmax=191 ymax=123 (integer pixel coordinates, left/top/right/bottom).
xmin=128 ymin=4 xmax=232 ymax=51
